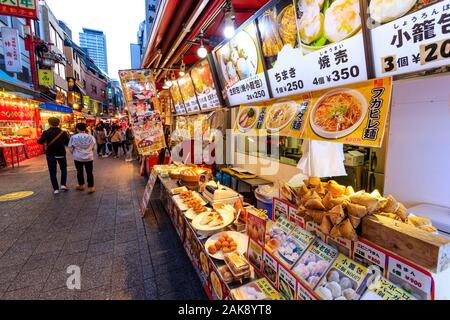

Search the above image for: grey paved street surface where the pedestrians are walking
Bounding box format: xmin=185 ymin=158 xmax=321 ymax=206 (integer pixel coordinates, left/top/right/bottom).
xmin=0 ymin=156 xmax=207 ymax=300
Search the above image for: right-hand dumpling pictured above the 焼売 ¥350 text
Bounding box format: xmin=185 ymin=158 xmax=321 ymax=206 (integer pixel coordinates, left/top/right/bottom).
xmin=325 ymin=0 xmax=361 ymax=42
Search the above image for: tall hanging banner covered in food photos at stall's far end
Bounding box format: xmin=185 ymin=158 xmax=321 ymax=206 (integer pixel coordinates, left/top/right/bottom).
xmin=119 ymin=69 xmax=166 ymax=155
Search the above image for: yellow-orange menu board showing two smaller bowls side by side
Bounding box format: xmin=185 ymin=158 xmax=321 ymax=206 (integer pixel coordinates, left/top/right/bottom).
xmin=234 ymin=94 xmax=311 ymax=138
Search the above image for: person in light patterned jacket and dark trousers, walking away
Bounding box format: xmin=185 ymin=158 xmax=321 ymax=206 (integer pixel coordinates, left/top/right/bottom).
xmin=69 ymin=123 xmax=95 ymax=193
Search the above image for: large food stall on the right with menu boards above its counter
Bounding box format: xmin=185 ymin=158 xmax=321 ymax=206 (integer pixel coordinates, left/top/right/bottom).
xmin=141 ymin=0 xmax=450 ymax=300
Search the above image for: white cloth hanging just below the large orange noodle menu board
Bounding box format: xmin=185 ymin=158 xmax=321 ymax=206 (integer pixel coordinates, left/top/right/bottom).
xmin=297 ymin=140 xmax=347 ymax=178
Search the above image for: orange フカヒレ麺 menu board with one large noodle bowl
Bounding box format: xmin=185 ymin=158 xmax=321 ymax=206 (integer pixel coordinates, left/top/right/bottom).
xmin=304 ymin=78 xmax=392 ymax=148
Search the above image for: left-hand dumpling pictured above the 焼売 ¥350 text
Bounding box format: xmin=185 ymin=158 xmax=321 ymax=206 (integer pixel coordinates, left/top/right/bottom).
xmin=299 ymin=6 xmax=324 ymax=44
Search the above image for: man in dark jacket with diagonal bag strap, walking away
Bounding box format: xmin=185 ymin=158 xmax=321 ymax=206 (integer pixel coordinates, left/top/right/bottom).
xmin=37 ymin=118 xmax=70 ymax=194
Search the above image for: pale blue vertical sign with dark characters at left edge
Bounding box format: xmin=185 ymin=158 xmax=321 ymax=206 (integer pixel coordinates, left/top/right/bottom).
xmin=1 ymin=27 xmax=22 ymax=72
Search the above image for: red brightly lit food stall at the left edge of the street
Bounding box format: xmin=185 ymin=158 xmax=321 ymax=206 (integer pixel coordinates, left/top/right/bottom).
xmin=0 ymin=91 xmax=43 ymax=167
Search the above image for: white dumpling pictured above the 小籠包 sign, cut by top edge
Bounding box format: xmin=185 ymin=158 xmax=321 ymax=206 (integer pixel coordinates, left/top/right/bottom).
xmin=369 ymin=0 xmax=417 ymax=23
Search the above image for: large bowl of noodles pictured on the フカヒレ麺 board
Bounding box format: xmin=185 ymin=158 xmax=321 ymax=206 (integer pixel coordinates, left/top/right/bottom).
xmin=310 ymin=89 xmax=367 ymax=139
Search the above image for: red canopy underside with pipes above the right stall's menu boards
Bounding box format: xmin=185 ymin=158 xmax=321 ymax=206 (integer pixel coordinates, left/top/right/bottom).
xmin=142 ymin=0 xmax=268 ymax=86
